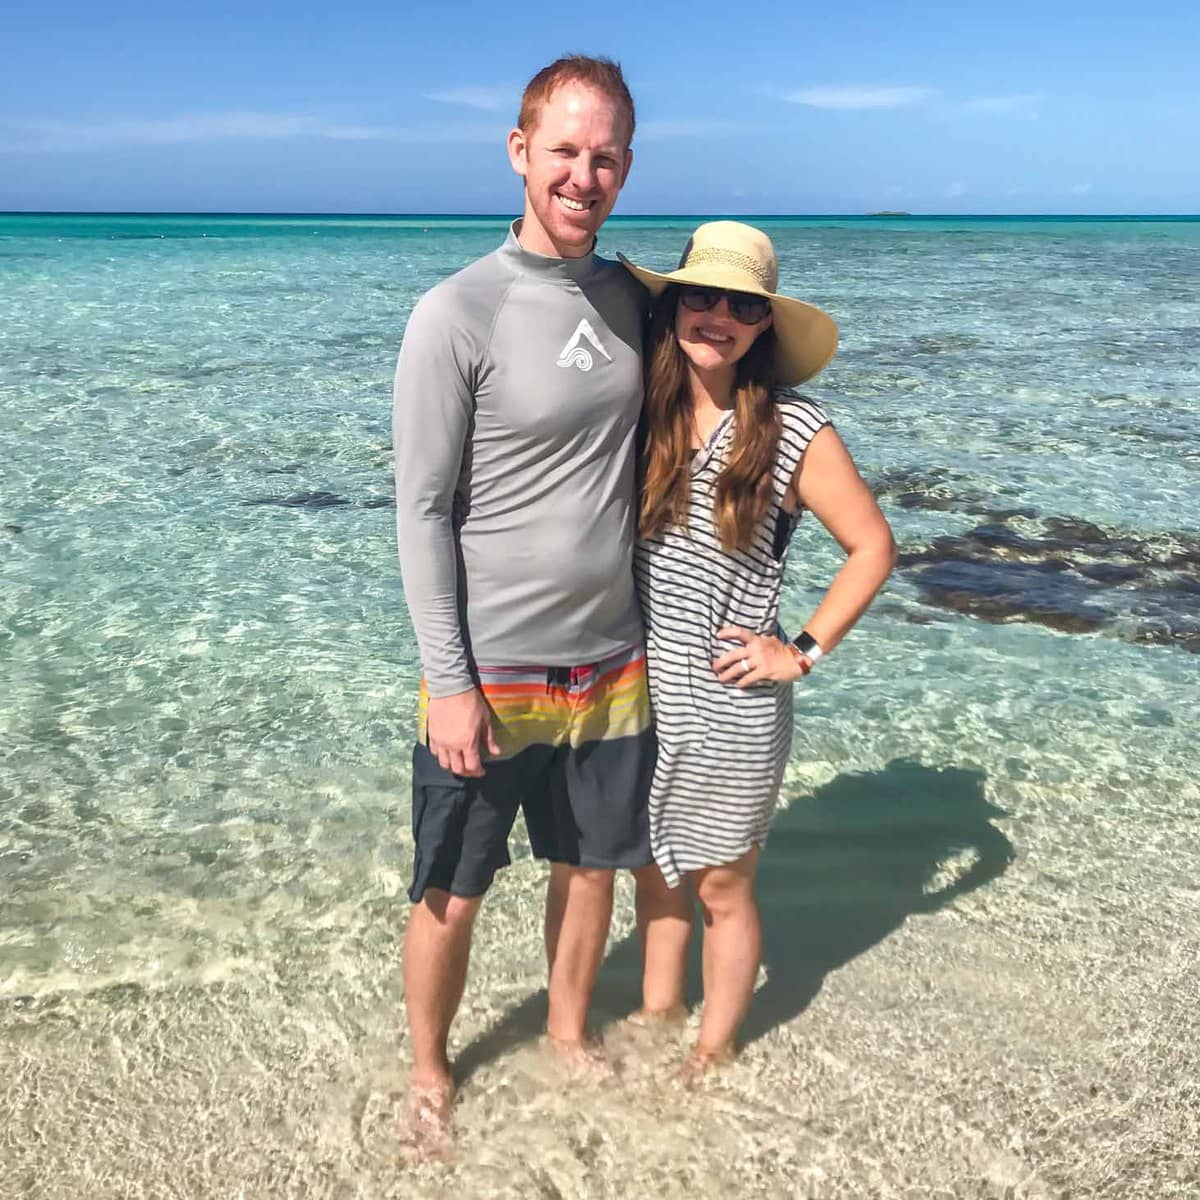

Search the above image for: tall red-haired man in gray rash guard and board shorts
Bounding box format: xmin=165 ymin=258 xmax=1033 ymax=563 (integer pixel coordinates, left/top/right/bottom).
xmin=394 ymin=56 xmax=654 ymax=1139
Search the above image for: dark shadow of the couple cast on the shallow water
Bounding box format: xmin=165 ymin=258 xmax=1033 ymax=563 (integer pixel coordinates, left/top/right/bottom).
xmin=458 ymin=758 xmax=1014 ymax=1079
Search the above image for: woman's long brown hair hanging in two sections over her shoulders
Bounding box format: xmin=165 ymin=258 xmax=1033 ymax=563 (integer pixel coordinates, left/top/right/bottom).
xmin=638 ymin=287 xmax=780 ymax=553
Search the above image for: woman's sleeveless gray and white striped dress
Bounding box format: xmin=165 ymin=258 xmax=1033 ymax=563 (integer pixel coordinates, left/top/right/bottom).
xmin=635 ymin=391 xmax=828 ymax=887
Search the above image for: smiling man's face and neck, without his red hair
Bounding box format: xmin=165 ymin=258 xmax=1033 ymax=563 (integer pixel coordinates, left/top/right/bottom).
xmin=509 ymin=83 xmax=634 ymax=258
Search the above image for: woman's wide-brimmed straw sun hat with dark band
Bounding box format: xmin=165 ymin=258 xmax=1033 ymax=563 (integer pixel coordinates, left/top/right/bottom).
xmin=617 ymin=221 xmax=838 ymax=386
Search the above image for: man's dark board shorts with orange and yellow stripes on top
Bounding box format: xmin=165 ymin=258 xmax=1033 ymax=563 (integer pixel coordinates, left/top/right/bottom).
xmin=409 ymin=644 xmax=655 ymax=901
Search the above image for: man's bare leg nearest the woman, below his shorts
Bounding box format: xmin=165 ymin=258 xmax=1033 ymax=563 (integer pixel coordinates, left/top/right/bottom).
xmin=546 ymin=863 xmax=616 ymax=1055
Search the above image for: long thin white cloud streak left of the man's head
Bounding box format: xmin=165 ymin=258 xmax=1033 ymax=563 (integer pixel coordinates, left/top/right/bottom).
xmin=0 ymin=112 xmax=503 ymax=154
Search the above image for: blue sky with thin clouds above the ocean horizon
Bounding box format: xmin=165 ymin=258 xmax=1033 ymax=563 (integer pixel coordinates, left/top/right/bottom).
xmin=0 ymin=0 xmax=1200 ymax=214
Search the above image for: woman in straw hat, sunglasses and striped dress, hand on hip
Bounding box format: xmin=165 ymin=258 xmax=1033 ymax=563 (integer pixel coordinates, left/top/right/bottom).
xmin=623 ymin=221 xmax=895 ymax=1079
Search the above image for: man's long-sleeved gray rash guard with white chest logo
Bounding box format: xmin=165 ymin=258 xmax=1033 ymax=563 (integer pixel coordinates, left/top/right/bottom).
xmin=392 ymin=224 xmax=646 ymax=697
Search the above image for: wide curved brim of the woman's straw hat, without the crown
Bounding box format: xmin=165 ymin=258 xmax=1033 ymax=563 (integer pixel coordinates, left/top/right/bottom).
xmin=617 ymin=253 xmax=838 ymax=388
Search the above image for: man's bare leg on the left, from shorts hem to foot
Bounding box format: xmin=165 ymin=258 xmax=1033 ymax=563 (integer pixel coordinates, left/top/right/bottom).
xmin=404 ymin=888 xmax=484 ymax=1152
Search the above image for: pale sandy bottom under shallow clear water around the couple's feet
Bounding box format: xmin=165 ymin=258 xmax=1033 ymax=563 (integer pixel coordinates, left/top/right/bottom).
xmin=0 ymin=764 xmax=1200 ymax=1200
